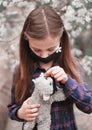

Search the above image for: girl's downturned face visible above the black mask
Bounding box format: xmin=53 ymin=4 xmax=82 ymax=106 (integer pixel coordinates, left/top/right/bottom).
xmin=27 ymin=36 xmax=60 ymax=58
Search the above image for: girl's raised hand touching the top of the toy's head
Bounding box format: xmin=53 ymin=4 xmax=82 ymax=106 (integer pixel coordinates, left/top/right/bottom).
xmin=45 ymin=66 xmax=68 ymax=84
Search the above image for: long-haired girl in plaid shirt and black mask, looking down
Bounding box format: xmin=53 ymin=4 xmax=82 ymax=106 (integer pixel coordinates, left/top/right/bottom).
xmin=8 ymin=6 xmax=92 ymax=130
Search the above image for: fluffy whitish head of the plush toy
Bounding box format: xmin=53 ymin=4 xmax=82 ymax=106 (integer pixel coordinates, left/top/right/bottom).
xmin=32 ymin=73 xmax=53 ymax=101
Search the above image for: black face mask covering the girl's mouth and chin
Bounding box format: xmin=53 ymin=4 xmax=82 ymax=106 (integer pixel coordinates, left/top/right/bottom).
xmin=31 ymin=47 xmax=60 ymax=63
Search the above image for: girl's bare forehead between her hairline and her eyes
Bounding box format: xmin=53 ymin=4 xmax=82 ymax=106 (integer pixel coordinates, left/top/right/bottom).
xmin=29 ymin=36 xmax=60 ymax=49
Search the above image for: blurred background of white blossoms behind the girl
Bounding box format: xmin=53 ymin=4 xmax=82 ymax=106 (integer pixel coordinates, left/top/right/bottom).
xmin=0 ymin=0 xmax=92 ymax=130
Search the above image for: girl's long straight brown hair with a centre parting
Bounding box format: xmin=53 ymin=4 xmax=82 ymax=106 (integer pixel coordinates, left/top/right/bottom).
xmin=14 ymin=6 xmax=81 ymax=104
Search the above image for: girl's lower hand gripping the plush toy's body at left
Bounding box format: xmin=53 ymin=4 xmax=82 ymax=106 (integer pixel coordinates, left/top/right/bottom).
xmin=17 ymin=98 xmax=40 ymax=121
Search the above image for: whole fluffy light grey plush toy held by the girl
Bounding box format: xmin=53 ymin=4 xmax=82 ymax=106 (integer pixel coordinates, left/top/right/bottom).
xmin=24 ymin=73 xmax=65 ymax=130
